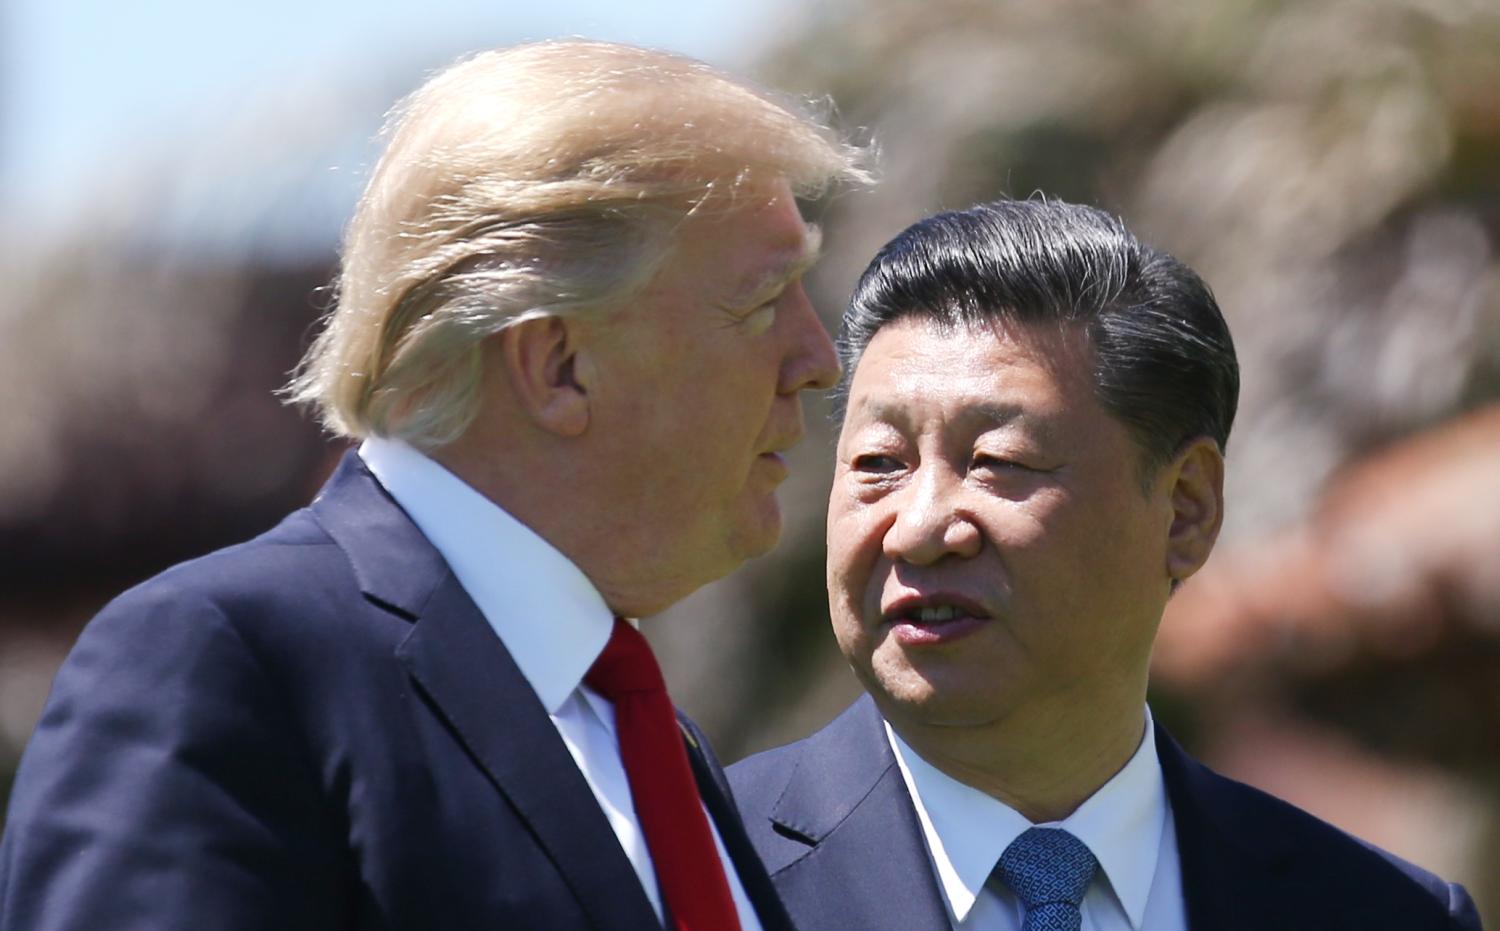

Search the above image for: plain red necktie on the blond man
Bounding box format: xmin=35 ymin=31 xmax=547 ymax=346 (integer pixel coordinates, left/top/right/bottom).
xmin=584 ymin=618 xmax=740 ymax=931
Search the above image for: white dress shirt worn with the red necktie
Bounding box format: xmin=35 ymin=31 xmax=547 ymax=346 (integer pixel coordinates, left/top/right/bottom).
xmin=360 ymin=438 xmax=761 ymax=931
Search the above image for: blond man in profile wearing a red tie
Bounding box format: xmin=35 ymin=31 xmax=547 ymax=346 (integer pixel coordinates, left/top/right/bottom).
xmin=0 ymin=40 xmax=863 ymax=931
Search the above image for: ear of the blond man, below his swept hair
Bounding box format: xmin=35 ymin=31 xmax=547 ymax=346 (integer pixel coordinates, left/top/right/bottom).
xmin=495 ymin=316 xmax=590 ymax=436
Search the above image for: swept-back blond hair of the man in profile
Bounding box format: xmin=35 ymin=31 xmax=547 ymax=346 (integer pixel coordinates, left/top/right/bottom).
xmin=285 ymin=40 xmax=867 ymax=448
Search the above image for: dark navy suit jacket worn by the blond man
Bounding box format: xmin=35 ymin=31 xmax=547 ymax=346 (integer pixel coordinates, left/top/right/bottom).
xmin=0 ymin=454 xmax=788 ymax=931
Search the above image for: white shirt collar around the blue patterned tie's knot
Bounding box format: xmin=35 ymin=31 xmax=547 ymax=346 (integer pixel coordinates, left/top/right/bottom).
xmin=885 ymin=708 xmax=1167 ymax=928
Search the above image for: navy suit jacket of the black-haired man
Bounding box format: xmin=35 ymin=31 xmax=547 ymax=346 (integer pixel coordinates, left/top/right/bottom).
xmin=729 ymin=696 xmax=1479 ymax=931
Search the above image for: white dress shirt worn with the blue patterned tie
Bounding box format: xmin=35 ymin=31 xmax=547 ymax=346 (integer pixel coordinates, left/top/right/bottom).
xmin=885 ymin=709 xmax=1188 ymax=931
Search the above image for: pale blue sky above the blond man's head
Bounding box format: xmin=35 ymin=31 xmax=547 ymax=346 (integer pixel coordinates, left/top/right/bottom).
xmin=0 ymin=0 xmax=806 ymax=242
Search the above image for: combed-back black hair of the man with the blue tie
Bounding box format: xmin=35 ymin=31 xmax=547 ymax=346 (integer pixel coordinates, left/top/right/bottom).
xmin=836 ymin=198 xmax=1239 ymax=472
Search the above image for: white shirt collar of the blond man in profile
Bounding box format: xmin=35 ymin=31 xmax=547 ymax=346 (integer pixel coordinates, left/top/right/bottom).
xmin=360 ymin=436 xmax=614 ymax=714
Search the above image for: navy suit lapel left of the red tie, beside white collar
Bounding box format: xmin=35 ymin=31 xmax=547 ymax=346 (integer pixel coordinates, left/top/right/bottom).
xmin=314 ymin=453 xmax=660 ymax=931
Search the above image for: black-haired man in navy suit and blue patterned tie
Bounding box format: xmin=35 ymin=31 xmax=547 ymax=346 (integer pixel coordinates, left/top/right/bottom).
xmin=731 ymin=199 xmax=1479 ymax=931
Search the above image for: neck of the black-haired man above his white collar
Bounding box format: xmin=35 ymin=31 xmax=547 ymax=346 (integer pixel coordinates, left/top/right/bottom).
xmin=887 ymin=685 xmax=1146 ymax=825
